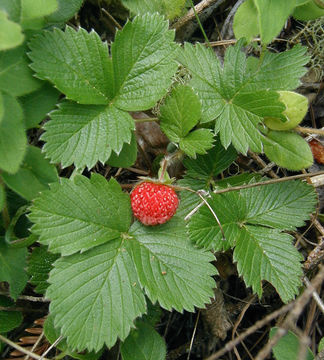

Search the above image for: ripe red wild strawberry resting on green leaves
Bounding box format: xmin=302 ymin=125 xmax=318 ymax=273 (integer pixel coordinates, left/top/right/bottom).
xmin=130 ymin=181 xmax=179 ymax=225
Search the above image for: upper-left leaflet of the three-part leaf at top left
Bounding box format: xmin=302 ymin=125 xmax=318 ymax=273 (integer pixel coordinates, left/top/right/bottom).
xmin=29 ymin=26 xmax=113 ymax=104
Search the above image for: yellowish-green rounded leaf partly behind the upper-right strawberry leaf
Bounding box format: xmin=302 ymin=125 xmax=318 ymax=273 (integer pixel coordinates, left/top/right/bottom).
xmin=264 ymin=91 xmax=308 ymax=130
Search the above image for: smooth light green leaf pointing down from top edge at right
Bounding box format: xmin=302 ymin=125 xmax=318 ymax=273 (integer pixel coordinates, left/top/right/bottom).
xmin=254 ymin=0 xmax=296 ymax=44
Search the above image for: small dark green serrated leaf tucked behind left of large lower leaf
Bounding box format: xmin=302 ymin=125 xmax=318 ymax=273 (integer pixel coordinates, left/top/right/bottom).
xmin=27 ymin=246 xmax=59 ymax=294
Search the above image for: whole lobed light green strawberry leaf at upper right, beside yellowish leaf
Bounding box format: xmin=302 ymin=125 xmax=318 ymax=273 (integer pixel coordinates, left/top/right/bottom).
xmin=179 ymin=42 xmax=308 ymax=154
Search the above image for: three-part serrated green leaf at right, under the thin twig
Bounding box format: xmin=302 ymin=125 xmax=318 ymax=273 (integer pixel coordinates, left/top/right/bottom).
xmin=188 ymin=181 xmax=317 ymax=302
